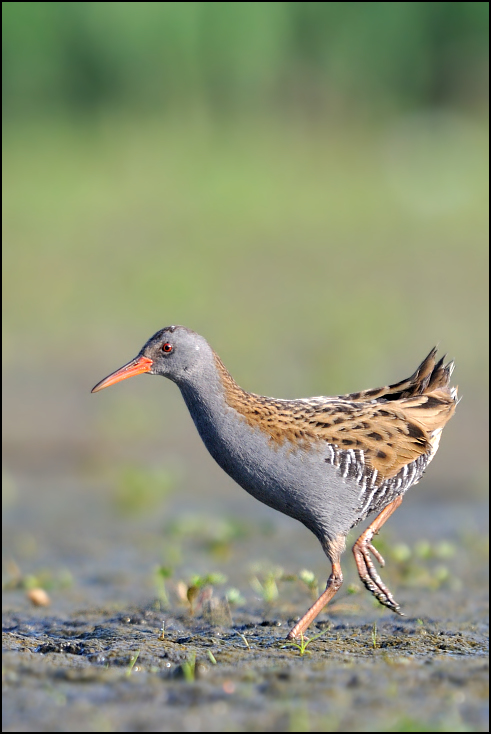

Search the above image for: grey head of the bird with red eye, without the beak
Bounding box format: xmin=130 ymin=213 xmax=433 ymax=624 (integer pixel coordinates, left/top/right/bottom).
xmin=140 ymin=326 xmax=211 ymax=383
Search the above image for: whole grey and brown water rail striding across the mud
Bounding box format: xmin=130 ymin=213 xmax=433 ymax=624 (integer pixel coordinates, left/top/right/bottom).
xmin=92 ymin=326 xmax=457 ymax=639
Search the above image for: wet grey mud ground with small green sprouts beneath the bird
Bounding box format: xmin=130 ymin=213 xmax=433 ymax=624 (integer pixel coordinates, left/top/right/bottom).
xmin=3 ymin=468 xmax=488 ymax=731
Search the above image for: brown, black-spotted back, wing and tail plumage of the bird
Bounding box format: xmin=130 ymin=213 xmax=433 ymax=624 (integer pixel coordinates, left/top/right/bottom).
xmin=215 ymin=349 xmax=457 ymax=498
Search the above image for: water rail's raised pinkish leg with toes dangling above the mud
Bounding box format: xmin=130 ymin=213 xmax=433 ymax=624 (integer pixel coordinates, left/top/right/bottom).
xmin=353 ymin=496 xmax=404 ymax=617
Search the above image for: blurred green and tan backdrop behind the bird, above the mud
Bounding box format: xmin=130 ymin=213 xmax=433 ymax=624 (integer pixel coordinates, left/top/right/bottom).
xmin=3 ymin=2 xmax=489 ymax=498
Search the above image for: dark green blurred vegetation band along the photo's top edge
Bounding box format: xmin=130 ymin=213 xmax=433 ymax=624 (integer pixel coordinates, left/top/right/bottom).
xmin=3 ymin=2 xmax=489 ymax=115
